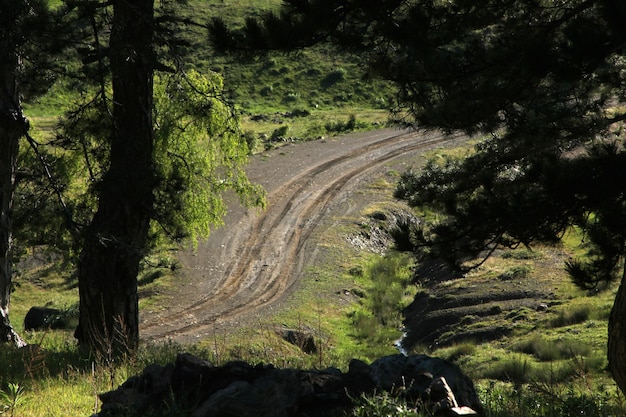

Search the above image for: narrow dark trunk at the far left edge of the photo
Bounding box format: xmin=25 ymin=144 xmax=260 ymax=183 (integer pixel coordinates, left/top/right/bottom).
xmin=0 ymin=25 xmax=27 ymax=347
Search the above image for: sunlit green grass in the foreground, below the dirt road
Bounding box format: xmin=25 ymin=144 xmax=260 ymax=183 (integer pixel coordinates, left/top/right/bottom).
xmin=0 ymin=173 xmax=626 ymax=417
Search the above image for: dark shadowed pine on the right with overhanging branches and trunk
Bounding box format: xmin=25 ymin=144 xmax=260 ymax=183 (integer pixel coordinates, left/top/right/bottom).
xmin=210 ymin=0 xmax=626 ymax=392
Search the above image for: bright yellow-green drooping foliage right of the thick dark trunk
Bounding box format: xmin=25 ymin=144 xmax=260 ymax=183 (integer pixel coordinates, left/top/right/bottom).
xmin=154 ymin=71 xmax=264 ymax=243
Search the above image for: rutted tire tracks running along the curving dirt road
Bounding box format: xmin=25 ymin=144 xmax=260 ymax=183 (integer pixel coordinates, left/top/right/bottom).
xmin=140 ymin=130 xmax=450 ymax=343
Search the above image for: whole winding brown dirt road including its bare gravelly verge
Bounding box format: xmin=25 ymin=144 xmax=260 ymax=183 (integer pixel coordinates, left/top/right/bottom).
xmin=140 ymin=129 xmax=454 ymax=343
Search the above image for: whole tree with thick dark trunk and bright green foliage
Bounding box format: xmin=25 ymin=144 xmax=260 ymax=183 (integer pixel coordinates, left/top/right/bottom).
xmin=51 ymin=0 xmax=264 ymax=357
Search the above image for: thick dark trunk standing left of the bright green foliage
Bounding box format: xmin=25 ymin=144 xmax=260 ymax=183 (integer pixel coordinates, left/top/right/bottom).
xmin=76 ymin=0 xmax=154 ymax=355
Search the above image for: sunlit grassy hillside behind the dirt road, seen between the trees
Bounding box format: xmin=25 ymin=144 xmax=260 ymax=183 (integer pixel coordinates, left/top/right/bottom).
xmin=25 ymin=0 xmax=393 ymax=146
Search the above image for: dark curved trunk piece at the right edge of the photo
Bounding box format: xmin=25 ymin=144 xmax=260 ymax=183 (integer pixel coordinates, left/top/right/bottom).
xmin=607 ymin=265 xmax=626 ymax=393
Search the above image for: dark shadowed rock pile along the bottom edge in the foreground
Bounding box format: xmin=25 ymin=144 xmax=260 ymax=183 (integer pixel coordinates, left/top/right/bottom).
xmin=98 ymin=354 xmax=482 ymax=417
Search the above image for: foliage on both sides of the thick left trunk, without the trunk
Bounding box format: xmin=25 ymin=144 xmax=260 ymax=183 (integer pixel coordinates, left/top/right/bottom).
xmin=15 ymin=0 xmax=264 ymax=256
